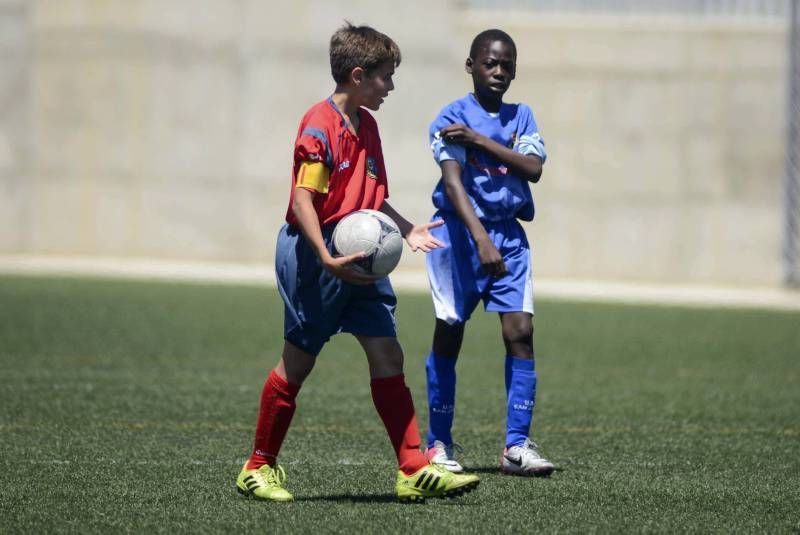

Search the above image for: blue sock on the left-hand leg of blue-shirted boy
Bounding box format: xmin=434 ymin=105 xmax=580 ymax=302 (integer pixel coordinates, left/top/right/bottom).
xmin=425 ymin=351 xmax=456 ymax=447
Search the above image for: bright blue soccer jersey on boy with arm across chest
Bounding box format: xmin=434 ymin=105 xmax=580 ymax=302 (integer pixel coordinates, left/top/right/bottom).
xmin=429 ymin=93 xmax=547 ymax=221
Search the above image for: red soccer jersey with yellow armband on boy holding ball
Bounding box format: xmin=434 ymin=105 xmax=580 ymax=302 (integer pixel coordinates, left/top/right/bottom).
xmin=286 ymin=98 xmax=389 ymax=226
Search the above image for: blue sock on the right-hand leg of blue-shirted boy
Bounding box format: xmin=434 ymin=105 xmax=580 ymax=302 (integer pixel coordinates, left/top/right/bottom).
xmin=506 ymin=355 xmax=536 ymax=447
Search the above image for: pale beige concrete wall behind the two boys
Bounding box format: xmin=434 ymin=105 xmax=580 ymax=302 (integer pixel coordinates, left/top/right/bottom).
xmin=0 ymin=0 xmax=785 ymax=285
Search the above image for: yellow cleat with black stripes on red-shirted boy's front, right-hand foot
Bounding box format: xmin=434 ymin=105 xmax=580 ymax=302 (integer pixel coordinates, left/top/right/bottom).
xmin=395 ymin=464 xmax=481 ymax=502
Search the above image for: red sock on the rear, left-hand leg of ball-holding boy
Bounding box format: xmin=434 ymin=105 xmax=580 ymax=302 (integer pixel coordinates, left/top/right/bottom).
xmin=247 ymin=370 xmax=300 ymax=470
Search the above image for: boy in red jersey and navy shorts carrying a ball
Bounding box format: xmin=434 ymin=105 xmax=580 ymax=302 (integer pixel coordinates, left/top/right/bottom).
xmin=236 ymin=23 xmax=479 ymax=501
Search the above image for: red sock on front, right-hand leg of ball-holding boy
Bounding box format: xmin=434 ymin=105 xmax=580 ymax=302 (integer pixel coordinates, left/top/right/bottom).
xmin=370 ymin=374 xmax=428 ymax=475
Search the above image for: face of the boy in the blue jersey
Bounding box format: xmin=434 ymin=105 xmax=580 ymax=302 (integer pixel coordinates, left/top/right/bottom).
xmin=466 ymin=41 xmax=517 ymax=101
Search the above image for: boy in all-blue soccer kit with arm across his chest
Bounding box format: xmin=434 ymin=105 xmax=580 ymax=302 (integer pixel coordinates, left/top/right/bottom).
xmin=426 ymin=30 xmax=555 ymax=476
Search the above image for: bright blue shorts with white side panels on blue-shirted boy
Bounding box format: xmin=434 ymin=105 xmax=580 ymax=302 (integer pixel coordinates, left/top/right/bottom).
xmin=426 ymin=211 xmax=533 ymax=325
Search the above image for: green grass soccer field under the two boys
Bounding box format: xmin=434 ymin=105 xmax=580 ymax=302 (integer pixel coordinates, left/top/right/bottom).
xmin=0 ymin=277 xmax=800 ymax=533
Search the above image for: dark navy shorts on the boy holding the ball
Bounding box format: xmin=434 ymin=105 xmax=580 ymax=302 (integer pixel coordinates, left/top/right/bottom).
xmin=275 ymin=225 xmax=397 ymax=356
